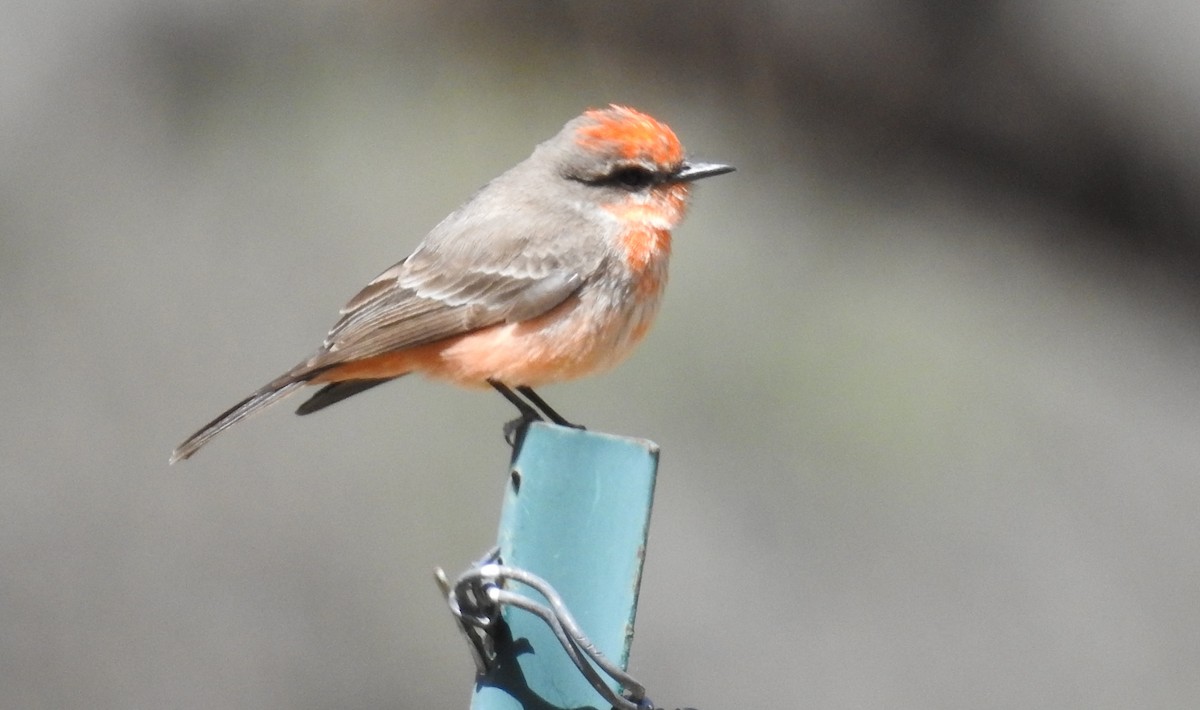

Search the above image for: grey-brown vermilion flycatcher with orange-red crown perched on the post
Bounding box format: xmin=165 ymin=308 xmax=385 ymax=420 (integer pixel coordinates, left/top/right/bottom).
xmin=170 ymin=106 xmax=733 ymax=463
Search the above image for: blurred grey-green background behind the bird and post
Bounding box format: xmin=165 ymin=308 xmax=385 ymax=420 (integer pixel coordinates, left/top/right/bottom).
xmin=0 ymin=0 xmax=1200 ymax=710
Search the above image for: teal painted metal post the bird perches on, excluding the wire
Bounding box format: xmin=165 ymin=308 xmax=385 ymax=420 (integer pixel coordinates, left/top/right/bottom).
xmin=470 ymin=423 xmax=659 ymax=710
